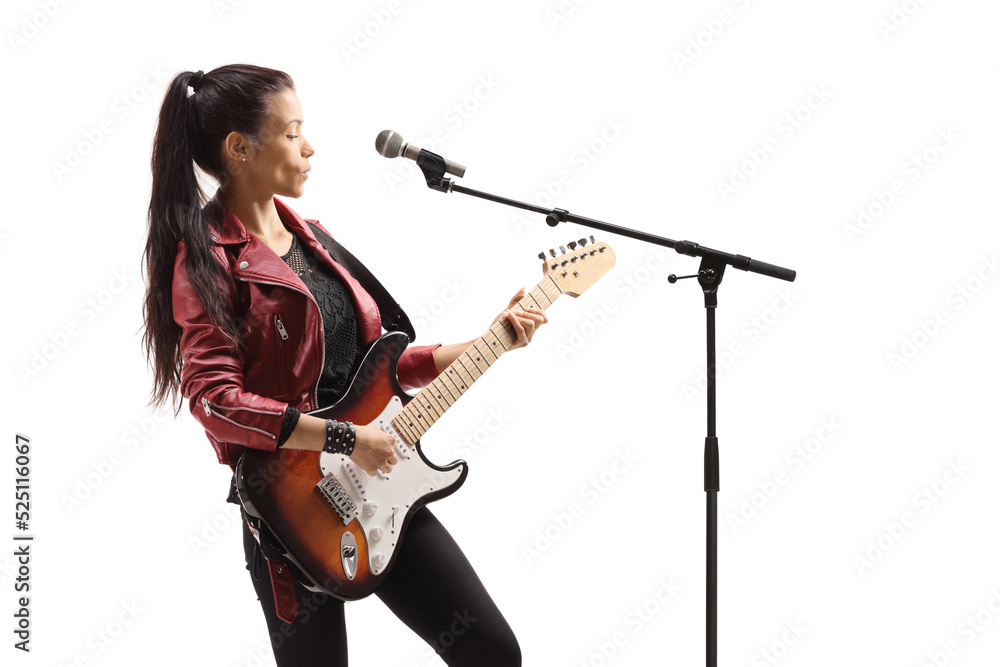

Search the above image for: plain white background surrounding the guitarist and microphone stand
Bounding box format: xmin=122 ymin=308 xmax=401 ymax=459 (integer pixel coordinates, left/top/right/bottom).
xmin=0 ymin=0 xmax=1000 ymax=667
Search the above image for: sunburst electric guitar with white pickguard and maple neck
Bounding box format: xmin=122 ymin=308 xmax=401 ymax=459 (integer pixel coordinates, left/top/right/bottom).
xmin=236 ymin=237 xmax=615 ymax=600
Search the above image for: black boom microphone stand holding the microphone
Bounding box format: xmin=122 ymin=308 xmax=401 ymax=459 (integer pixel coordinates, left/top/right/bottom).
xmin=417 ymin=150 xmax=795 ymax=667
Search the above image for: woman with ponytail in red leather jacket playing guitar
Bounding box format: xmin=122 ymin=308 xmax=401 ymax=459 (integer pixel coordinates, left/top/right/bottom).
xmin=144 ymin=65 xmax=547 ymax=666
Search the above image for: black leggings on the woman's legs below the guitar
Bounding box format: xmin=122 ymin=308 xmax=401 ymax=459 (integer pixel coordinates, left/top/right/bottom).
xmin=243 ymin=507 xmax=521 ymax=667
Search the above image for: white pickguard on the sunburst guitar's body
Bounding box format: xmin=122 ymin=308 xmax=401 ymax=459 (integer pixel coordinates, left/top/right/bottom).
xmin=319 ymin=396 xmax=465 ymax=574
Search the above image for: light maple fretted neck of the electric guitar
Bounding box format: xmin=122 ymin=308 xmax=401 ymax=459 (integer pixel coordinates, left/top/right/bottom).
xmin=392 ymin=275 xmax=563 ymax=445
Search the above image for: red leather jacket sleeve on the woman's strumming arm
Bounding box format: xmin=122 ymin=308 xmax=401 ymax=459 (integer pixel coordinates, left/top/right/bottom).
xmin=172 ymin=241 xmax=288 ymax=451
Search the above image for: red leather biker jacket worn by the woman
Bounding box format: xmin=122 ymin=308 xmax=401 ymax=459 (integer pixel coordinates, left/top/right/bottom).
xmin=173 ymin=194 xmax=440 ymax=469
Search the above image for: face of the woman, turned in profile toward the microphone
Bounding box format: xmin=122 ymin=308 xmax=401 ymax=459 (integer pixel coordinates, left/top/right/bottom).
xmin=232 ymin=89 xmax=315 ymax=198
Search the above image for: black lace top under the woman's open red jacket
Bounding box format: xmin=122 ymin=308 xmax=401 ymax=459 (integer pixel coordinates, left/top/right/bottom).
xmin=278 ymin=234 xmax=360 ymax=447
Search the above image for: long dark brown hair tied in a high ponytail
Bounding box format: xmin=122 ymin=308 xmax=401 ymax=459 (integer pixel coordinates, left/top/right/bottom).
xmin=143 ymin=65 xmax=295 ymax=414
